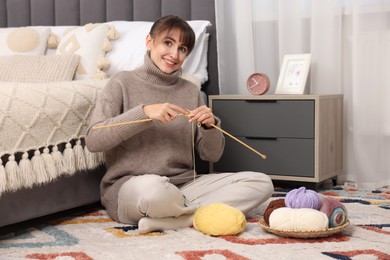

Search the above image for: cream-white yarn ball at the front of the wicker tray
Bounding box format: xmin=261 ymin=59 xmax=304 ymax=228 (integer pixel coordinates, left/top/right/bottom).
xmin=269 ymin=207 xmax=329 ymax=232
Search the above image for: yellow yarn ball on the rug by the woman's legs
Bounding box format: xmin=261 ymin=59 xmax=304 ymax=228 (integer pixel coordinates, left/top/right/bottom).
xmin=193 ymin=203 xmax=246 ymax=236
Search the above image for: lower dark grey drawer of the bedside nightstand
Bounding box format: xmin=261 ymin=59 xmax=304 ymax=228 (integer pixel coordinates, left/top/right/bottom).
xmin=213 ymin=137 xmax=314 ymax=177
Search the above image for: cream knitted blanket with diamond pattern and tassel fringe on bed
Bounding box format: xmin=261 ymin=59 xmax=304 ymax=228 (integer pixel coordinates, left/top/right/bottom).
xmin=0 ymin=80 xmax=107 ymax=194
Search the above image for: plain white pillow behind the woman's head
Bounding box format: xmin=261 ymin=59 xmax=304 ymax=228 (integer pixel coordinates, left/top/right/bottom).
xmin=106 ymin=20 xmax=211 ymax=84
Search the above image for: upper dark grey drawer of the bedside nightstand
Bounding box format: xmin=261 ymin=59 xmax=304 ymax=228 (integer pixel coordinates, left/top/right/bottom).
xmin=212 ymin=99 xmax=314 ymax=138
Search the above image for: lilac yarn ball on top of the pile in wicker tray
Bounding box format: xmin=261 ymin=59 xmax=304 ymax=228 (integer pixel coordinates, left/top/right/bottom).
xmin=285 ymin=187 xmax=321 ymax=210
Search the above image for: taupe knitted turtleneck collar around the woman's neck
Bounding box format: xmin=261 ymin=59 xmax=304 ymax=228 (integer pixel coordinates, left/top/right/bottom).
xmin=136 ymin=53 xmax=182 ymax=86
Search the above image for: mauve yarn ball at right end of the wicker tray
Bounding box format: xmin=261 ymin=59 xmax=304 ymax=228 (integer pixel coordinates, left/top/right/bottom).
xmin=320 ymin=196 xmax=348 ymax=228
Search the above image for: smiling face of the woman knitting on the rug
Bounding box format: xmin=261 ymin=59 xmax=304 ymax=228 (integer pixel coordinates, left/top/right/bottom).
xmin=146 ymin=29 xmax=188 ymax=74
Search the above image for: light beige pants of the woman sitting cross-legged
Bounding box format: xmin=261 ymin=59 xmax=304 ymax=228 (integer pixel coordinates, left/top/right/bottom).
xmin=118 ymin=172 xmax=273 ymax=225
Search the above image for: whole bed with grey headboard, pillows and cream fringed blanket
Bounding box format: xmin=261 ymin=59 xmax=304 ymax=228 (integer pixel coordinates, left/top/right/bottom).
xmin=0 ymin=0 xmax=219 ymax=227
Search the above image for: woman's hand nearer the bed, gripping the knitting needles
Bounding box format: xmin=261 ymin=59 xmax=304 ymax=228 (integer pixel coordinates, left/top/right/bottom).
xmin=144 ymin=103 xmax=188 ymax=123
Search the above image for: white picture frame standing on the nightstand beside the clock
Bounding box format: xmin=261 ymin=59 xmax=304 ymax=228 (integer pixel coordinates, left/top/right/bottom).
xmin=275 ymin=53 xmax=311 ymax=94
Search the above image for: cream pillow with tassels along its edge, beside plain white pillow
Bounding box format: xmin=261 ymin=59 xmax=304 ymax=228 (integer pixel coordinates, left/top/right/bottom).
xmin=56 ymin=23 xmax=118 ymax=80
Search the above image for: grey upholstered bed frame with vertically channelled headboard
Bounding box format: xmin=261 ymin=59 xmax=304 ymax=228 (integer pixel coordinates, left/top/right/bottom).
xmin=0 ymin=0 xmax=219 ymax=227
